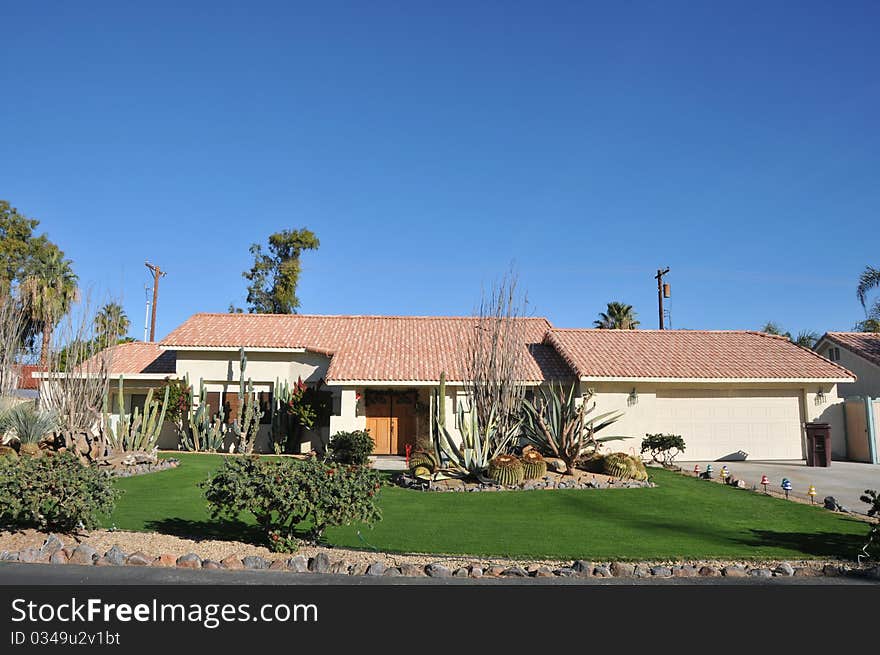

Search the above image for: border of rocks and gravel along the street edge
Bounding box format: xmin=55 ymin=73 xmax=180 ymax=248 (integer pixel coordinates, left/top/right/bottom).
xmin=0 ymin=534 xmax=880 ymax=580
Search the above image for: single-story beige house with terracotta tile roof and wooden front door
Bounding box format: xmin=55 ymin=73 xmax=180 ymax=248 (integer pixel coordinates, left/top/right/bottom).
xmin=82 ymin=314 xmax=855 ymax=460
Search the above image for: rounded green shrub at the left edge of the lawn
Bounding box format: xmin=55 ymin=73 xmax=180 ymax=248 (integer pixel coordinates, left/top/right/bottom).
xmin=0 ymin=453 xmax=120 ymax=532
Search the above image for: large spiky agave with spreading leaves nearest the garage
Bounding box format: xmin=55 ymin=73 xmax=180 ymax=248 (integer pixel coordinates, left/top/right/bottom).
xmin=522 ymin=384 xmax=626 ymax=473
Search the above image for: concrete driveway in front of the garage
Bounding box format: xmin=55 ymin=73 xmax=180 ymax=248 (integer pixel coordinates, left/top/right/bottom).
xmin=676 ymin=460 xmax=880 ymax=514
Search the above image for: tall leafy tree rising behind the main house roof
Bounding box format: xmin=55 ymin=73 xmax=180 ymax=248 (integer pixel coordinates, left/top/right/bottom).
xmin=241 ymin=229 xmax=321 ymax=314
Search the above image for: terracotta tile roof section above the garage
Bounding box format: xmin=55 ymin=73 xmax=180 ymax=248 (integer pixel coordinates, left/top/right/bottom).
xmin=546 ymin=329 xmax=855 ymax=380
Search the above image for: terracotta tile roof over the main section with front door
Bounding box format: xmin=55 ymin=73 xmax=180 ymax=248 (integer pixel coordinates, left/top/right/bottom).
xmin=161 ymin=314 xmax=571 ymax=382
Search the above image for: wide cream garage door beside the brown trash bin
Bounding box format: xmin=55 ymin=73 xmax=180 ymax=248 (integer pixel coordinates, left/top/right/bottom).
xmin=656 ymin=389 xmax=803 ymax=460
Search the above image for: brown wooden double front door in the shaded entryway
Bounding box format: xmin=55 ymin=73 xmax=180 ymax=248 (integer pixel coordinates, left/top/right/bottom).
xmin=364 ymin=391 xmax=417 ymax=455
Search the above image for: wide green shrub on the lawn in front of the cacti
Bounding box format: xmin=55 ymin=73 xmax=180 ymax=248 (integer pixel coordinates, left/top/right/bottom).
xmin=202 ymin=456 xmax=382 ymax=552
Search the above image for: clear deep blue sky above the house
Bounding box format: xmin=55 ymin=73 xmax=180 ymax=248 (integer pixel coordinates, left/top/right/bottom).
xmin=0 ymin=1 xmax=880 ymax=337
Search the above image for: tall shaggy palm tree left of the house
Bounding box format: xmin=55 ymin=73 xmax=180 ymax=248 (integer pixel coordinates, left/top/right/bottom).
xmin=21 ymin=245 xmax=78 ymax=367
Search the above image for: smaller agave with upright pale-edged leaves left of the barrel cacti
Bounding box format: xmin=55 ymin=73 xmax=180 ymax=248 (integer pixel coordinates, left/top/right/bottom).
xmin=437 ymin=404 xmax=513 ymax=477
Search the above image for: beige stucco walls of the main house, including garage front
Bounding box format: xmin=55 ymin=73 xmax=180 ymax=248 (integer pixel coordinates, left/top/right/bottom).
xmin=96 ymin=349 xmax=849 ymax=461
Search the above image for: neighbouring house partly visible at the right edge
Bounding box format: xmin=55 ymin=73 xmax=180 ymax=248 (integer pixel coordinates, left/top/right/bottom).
xmin=815 ymin=332 xmax=880 ymax=464
